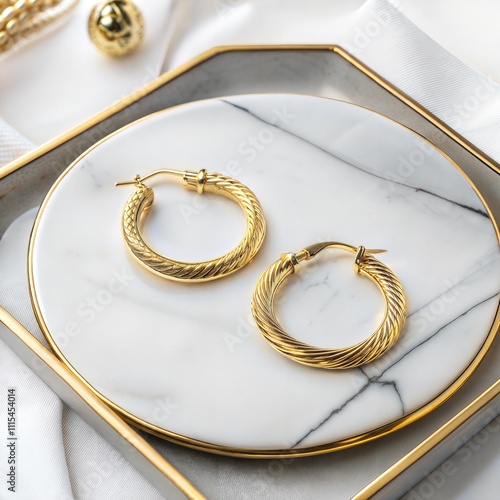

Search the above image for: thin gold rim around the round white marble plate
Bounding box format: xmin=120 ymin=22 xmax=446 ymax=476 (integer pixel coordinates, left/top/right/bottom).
xmin=28 ymin=79 xmax=500 ymax=458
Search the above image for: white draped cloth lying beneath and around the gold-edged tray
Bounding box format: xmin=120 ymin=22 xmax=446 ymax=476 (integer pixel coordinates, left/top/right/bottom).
xmin=0 ymin=0 xmax=500 ymax=500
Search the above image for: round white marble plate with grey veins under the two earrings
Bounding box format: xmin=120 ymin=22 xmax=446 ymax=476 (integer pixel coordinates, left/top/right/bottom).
xmin=30 ymin=94 xmax=500 ymax=455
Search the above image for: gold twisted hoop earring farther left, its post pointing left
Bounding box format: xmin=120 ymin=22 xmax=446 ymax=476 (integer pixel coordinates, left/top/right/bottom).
xmin=116 ymin=170 xmax=266 ymax=282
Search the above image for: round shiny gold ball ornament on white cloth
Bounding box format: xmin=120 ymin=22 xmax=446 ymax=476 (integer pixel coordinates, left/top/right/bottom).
xmin=89 ymin=0 xmax=144 ymax=56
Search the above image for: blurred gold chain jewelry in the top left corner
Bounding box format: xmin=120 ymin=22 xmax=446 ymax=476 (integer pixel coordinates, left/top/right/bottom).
xmin=0 ymin=0 xmax=78 ymax=53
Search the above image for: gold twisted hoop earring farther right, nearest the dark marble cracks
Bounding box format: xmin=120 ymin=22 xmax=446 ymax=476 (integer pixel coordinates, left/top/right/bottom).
xmin=252 ymin=242 xmax=406 ymax=370
